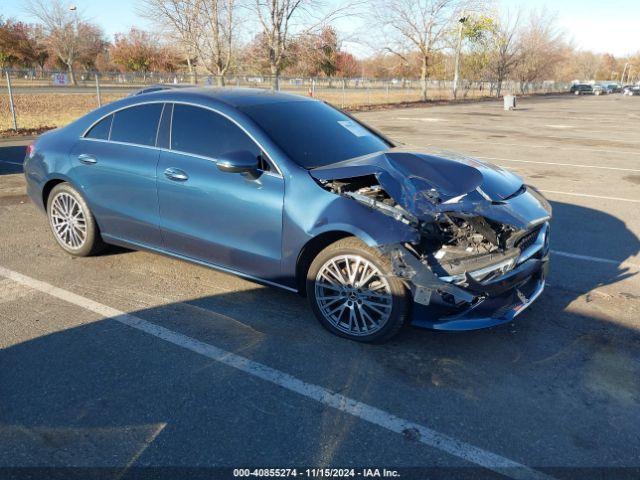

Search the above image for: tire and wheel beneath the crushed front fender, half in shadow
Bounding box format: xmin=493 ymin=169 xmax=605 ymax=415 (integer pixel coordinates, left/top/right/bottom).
xmin=306 ymin=237 xmax=411 ymax=343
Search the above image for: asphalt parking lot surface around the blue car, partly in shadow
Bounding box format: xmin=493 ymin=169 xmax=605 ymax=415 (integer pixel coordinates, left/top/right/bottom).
xmin=0 ymin=95 xmax=640 ymax=478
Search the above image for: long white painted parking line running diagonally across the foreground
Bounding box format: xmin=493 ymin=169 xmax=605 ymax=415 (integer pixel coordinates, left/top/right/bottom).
xmin=0 ymin=267 xmax=552 ymax=480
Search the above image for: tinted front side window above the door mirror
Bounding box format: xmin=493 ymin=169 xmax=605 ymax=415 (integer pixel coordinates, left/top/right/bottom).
xmin=171 ymin=104 xmax=260 ymax=158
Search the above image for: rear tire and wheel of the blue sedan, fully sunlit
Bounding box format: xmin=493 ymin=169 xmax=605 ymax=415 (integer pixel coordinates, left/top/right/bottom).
xmin=47 ymin=183 xmax=105 ymax=257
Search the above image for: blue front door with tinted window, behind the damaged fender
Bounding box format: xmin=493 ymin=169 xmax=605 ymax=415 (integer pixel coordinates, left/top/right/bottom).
xmin=158 ymin=104 xmax=284 ymax=283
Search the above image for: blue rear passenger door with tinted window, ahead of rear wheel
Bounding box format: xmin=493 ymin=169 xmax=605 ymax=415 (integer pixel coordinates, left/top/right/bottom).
xmin=71 ymin=103 xmax=164 ymax=247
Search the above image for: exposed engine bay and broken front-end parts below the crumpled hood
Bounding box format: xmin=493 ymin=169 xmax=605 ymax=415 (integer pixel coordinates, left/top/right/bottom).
xmin=319 ymin=168 xmax=546 ymax=312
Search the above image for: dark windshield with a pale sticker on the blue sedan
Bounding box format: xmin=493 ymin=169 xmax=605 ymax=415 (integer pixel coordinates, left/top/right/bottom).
xmin=243 ymin=101 xmax=390 ymax=168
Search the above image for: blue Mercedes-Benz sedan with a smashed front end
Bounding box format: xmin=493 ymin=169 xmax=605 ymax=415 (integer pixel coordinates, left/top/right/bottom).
xmin=24 ymin=88 xmax=551 ymax=342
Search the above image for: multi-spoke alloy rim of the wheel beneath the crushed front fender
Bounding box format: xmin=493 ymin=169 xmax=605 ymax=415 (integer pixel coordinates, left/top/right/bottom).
xmin=315 ymin=255 xmax=393 ymax=336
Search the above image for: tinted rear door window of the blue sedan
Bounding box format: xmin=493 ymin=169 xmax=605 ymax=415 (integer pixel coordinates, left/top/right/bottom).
xmin=110 ymin=103 xmax=162 ymax=146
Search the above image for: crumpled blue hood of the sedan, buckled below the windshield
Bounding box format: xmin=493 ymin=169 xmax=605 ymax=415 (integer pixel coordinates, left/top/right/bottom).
xmin=309 ymin=148 xmax=523 ymax=217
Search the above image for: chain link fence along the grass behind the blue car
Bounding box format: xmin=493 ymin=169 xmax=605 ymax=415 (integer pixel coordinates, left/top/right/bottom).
xmin=0 ymin=69 xmax=570 ymax=131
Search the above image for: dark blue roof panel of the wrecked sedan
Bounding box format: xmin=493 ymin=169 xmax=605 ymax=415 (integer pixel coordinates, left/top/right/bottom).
xmin=138 ymin=87 xmax=313 ymax=108
